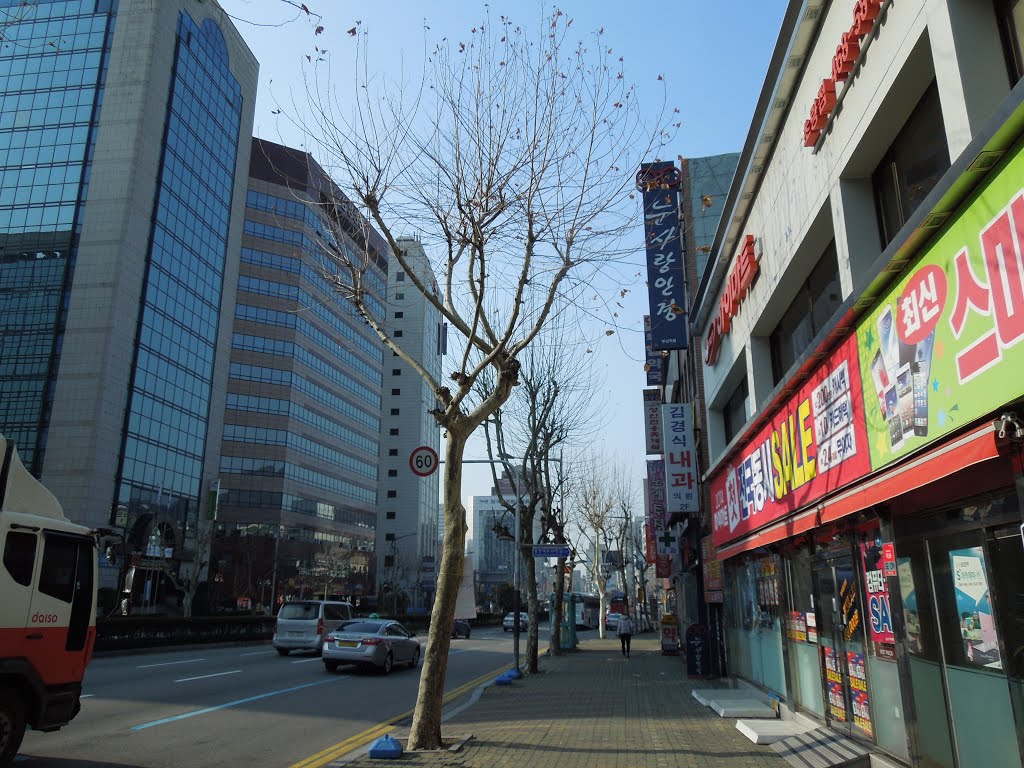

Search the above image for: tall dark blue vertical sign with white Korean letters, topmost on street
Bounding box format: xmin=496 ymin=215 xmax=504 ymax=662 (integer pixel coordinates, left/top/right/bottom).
xmin=637 ymin=162 xmax=687 ymax=351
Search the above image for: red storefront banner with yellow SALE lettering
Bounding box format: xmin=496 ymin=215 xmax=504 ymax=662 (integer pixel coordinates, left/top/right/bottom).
xmin=711 ymin=336 xmax=870 ymax=547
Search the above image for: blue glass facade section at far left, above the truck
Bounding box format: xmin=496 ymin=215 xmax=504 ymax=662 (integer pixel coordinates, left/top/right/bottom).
xmin=0 ymin=0 xmax=117 ymax=475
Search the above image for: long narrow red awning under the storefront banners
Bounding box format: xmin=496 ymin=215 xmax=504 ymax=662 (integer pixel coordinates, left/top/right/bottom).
xmin=718 ymin=422 xmax=999 ymax=560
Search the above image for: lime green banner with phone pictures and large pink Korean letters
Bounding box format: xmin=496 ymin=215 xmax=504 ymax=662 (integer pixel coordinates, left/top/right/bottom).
xmin=857 ymin=146 xmax=1024 ymax=469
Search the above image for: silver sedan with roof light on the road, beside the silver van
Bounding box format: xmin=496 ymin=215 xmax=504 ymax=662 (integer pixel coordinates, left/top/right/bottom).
xmin=324 ymin=618 xmax=420 ymax=675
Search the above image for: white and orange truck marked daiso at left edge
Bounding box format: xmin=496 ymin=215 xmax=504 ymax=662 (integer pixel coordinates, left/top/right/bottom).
xmin=0 ymin=435 xmax=97 ymax=768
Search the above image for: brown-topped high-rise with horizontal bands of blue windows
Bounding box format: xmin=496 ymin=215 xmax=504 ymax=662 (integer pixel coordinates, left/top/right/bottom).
xmin=215 ymin=139 xmax=387 ymax=601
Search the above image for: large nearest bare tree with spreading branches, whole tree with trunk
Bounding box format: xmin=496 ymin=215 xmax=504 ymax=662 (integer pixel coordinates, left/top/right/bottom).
xmin=284 ymin=10 xmax=670 ymax=750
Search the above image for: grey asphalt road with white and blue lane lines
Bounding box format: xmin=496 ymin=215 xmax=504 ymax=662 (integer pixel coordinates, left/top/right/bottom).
xmin=14 ymin=628 xmax=547 ymax=768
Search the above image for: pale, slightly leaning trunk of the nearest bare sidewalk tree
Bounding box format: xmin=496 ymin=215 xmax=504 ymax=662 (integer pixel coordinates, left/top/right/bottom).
xmin=409 ymin=426 xmax=468 ymax=750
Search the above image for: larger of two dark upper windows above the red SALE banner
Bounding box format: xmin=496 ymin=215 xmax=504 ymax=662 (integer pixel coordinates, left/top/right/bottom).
xmin=770 ymin=241 xmax=843 ymax=384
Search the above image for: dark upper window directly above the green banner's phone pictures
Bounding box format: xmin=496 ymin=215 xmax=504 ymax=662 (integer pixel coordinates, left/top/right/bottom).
xmin=871 ymin=81 xmax=949 ymax=248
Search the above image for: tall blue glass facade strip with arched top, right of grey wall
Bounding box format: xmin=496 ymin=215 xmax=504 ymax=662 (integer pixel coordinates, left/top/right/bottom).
xmin=117 ymin=12 xmax=242 ymax=520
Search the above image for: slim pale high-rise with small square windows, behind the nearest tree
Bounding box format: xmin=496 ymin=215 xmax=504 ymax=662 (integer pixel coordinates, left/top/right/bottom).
xmin=377 ymin=238 xmax=444 ymax=607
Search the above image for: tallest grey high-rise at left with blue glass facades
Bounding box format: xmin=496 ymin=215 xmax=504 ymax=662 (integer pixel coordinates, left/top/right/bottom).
xmin=0 ymin=0 xmax=258 ymax=599
